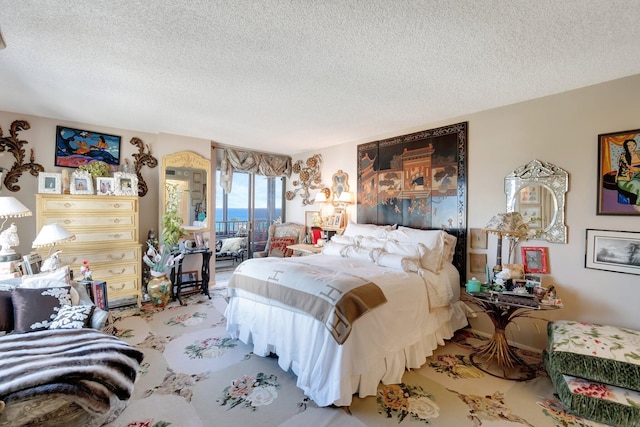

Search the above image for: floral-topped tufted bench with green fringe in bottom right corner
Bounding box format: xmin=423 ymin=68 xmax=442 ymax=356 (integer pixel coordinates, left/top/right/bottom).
xmin=543 ymin=320 xmax=640 ymax=426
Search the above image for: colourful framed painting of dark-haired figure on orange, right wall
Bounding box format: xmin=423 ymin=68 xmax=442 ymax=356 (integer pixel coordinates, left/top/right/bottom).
xmin=597 ymin=129 xmax=640 ymax=215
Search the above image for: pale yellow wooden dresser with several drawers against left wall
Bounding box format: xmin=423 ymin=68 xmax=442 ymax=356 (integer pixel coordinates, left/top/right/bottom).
xmin=36 ymin=194 xmax=142 ymax=305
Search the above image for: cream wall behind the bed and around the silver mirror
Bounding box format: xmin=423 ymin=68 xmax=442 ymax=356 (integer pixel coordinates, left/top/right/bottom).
xmin=287 ymin=75 xmax=640 ymax=348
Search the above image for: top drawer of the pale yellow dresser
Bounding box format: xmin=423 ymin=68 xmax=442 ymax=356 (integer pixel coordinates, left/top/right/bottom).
xmin=42 ymin=196 xmax=138 ymax=216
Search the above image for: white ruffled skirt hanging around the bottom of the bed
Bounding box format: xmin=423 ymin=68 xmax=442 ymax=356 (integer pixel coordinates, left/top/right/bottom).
xmin=225 ymin=298 xmax=468 ymax=406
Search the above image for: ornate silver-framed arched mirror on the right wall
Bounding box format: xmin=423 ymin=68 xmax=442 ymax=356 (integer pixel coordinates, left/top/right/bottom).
xmin=504 ymin=160 xmax=569 ymax=243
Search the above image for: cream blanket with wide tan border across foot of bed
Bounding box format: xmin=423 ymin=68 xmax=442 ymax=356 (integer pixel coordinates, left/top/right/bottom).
xmin=227 ymin=257 xmax=387 ymax=344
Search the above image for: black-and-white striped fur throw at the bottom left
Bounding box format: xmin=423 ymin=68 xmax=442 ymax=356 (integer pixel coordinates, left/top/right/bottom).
xmin=0 ymin=329 xmax=143 ymax=415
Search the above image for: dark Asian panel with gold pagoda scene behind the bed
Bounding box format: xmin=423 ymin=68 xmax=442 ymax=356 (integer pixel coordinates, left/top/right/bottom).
xmin=358 ymin=122 xmax=467 ymax=281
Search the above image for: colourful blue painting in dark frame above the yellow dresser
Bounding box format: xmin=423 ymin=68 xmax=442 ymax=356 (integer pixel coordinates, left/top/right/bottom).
xmin=55 ymin=126 xmax=121 ymax=168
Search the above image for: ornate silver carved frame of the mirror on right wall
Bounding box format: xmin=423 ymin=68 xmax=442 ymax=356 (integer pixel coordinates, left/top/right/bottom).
xmin=504 ymin=160 xmax=569 ymax=243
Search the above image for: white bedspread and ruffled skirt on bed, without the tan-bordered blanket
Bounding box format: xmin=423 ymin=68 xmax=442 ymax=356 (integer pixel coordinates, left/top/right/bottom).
xmin=225 ymin=254 xmax=467 ymax=406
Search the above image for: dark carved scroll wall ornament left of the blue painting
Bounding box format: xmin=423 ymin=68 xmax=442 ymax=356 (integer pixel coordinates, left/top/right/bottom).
xmin=0 ymin=120 xmax=44 ymax=192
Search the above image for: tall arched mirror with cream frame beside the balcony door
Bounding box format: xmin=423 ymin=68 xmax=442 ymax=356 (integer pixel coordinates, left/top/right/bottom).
xmin=161 ymin=151 xmax=211 ymax=231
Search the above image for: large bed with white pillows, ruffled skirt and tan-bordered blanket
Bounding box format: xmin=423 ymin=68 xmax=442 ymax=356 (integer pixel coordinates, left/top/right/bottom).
xmin=225 ymin=223 xmax=467 ymax=406
